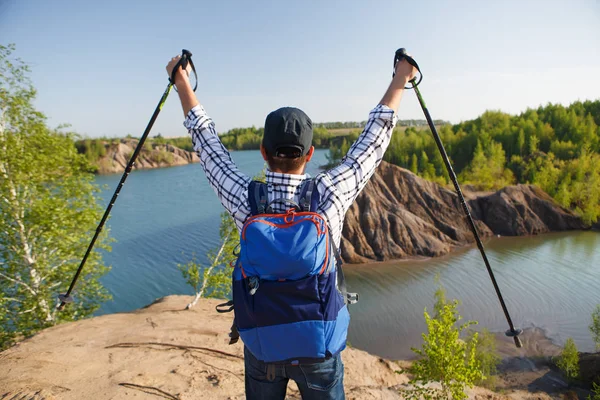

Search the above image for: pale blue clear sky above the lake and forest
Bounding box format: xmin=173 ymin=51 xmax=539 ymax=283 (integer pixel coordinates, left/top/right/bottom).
xmin=0 ymin=0 xmax=600 ymax=137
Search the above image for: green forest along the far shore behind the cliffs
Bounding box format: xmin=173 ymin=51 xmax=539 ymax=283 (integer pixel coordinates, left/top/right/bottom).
xmin=76 ymin=100 xmax=600 ymax=223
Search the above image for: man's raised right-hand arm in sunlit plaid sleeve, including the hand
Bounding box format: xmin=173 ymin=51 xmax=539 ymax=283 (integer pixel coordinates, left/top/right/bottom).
xmin=326 ymin=60 xmax=417 ymax=212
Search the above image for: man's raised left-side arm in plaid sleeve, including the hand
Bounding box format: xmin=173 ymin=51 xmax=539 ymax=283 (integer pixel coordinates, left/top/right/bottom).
xmin=167 ymin=56 xmax=251 ymax=225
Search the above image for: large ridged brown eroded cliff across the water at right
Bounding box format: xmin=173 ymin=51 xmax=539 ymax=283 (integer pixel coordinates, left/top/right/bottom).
xmin=341 ymin=162 xmax=587 ymax=263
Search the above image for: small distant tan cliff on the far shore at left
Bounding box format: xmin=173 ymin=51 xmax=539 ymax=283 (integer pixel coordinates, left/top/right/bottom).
xmin=98 ymin=139 xmax=200 ymax=174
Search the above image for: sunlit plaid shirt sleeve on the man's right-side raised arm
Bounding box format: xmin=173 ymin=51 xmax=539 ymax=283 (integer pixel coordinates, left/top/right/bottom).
xmin=326 ymin=104 xmax=396 ymax=213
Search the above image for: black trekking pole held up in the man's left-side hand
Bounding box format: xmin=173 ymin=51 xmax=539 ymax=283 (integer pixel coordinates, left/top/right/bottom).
xmin=57 ymin=49 xmax=198 ymax=311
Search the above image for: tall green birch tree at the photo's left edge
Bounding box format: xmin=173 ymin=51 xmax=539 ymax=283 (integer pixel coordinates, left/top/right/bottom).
xmin=0 ymin=45 xmax=109 ymax=348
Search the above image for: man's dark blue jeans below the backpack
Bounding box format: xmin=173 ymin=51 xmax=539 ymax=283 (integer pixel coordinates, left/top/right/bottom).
xmin=244 ymin=347 xmax=345 ymax=400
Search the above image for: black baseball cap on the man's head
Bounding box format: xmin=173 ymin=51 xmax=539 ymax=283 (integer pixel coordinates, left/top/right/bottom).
xmin=263 ymin=107 xmax=313 ymax=156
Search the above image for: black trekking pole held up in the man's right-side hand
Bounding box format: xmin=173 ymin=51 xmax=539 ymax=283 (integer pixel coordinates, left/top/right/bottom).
xmin=392 ymin=48 xmax=523 ymax=348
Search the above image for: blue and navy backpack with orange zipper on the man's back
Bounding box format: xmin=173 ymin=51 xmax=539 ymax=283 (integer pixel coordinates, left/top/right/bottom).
xmin=221 ymin=179 xmax=358 ymax=363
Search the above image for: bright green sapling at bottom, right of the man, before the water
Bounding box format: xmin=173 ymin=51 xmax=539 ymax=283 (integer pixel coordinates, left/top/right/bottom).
xmin=405 ymin=286 xmax=484 ymax=400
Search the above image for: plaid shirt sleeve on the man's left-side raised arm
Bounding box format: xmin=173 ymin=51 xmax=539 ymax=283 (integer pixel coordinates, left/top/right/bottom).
xmin=183 ymin=105 xmax=251 ymax=218
